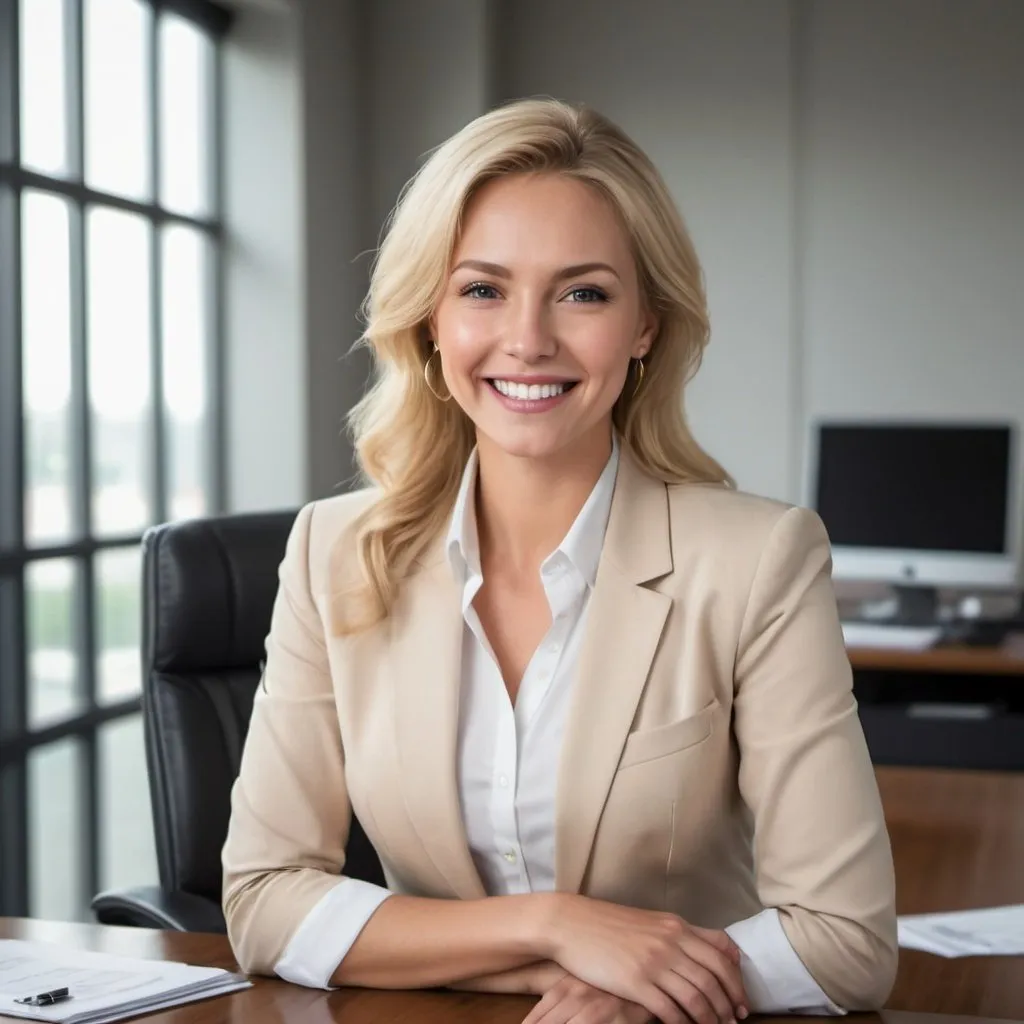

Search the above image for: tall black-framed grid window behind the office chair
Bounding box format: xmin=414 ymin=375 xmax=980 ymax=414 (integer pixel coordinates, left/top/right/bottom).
xmin=0 ymin=0 xmax=228 ymax=920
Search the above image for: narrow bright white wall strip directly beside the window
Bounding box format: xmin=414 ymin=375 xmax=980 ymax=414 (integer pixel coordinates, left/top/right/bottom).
xmin=223 ymin=0 xmax=308 ymax=511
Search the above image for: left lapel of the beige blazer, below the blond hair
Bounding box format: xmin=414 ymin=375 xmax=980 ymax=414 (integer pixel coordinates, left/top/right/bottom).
xmin=389 ymin=544 xmax=486 ymax=899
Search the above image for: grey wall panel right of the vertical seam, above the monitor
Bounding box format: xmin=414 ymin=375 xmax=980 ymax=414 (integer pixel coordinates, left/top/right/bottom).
xmin=800 ymin=0 xmax=1024 ymax=514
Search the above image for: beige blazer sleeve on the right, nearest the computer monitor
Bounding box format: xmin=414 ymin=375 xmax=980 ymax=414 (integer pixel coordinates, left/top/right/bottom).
xmin=734 ymin=508 xmax=897 ymax=1010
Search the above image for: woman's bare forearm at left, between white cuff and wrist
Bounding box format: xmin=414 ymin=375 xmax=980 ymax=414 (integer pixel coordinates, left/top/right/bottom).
xmin=331 ymin=893 xmax=557 ymax=988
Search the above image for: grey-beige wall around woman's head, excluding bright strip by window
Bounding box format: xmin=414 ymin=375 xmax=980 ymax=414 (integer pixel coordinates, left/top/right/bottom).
xmin=228 ymin=0 xmax=1024 ymax=569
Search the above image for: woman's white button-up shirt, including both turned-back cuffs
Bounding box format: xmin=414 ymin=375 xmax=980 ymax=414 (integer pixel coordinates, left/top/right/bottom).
xmin=274 ymin=438 xmax=845 ymax=1015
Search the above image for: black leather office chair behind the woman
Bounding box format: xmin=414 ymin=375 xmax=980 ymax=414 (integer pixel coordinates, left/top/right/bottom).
xmin=92 ymin=512 xmax=385 ymax=932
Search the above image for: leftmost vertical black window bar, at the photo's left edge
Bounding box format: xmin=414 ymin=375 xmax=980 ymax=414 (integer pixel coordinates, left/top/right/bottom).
xmin=0 ymin=0 xmax=29 ymax=916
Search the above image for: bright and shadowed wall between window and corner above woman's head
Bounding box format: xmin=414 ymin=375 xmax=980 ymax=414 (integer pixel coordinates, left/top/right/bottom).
xmin=225 ymin=0 xmax=490 ymax=511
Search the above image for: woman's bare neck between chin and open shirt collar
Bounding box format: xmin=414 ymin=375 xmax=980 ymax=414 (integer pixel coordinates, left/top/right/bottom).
xmin=476 ymin=430 xmax=611 ymax=579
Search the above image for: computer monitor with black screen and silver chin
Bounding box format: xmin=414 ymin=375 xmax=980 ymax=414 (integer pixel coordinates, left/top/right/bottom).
xmin=811 ymin=423 xmax=1020 ymax=622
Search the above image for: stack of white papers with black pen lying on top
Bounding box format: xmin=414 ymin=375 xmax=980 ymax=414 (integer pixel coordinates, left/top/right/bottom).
xmin=0 ymin=939 xmax=252 ymax=1024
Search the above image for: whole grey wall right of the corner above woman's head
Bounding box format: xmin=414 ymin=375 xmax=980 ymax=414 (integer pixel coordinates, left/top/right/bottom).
xmin=499 ymin=0 xmax=1024 ymax=528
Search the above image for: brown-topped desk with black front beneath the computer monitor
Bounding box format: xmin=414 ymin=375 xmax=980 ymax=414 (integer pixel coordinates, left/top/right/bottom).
xmin=849 ymin=635 xmax=1024 ymax=771
